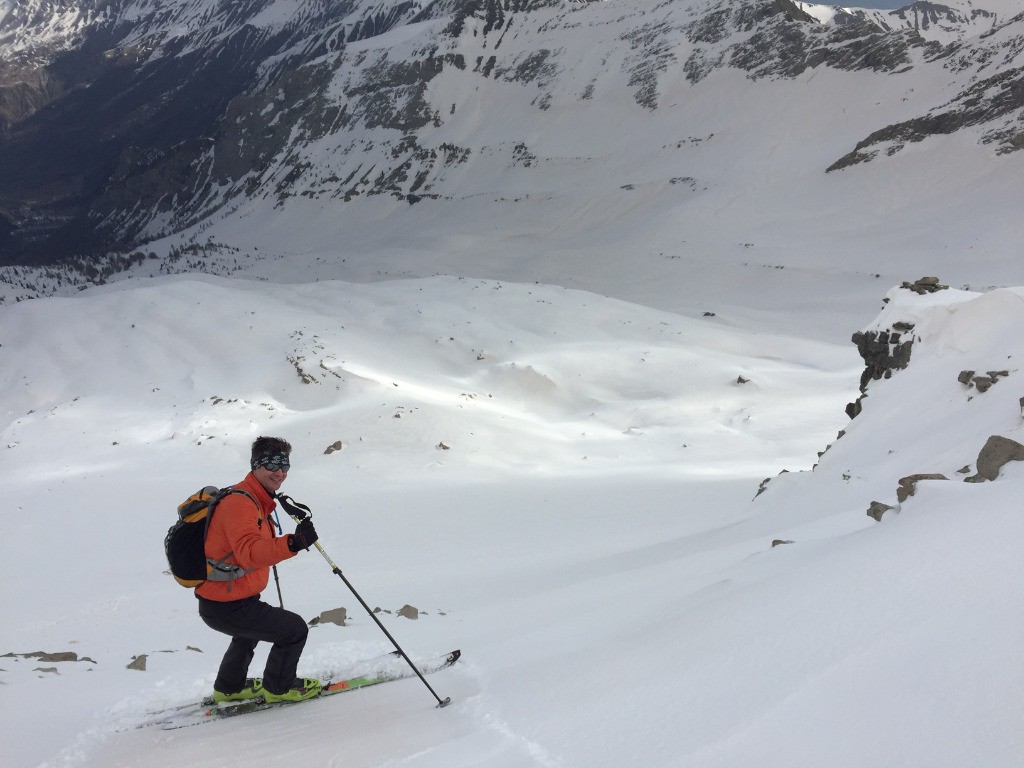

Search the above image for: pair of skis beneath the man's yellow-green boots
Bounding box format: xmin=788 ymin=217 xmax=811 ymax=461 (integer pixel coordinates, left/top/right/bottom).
xmin=137 ymin=650 xmax=462 ymax=730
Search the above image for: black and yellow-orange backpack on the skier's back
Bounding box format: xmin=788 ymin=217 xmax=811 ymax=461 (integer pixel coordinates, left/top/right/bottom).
xmin=164 ymin=485 xmax=259 ymax=588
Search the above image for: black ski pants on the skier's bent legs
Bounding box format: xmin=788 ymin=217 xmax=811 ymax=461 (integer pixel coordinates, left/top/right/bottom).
xmin=199 ymin=595 xmax=309 ymax=693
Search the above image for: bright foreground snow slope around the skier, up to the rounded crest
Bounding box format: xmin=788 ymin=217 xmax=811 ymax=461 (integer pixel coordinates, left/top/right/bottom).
xmin=0 ymin=268 xmax=1024 ymax=768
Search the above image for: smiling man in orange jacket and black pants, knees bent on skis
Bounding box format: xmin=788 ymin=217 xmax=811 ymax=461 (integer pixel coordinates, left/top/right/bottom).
xmin=196 ymin=437 xmax=322 ymax=702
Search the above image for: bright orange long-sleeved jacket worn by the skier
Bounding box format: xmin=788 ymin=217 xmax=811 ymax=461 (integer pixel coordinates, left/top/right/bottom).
xmin=196 ymin=472 xmax=295 ymax=602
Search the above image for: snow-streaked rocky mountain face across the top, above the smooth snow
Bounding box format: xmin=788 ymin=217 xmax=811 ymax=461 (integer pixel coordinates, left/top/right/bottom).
xmin=0 ymin=0 xmax=1024 ymax=264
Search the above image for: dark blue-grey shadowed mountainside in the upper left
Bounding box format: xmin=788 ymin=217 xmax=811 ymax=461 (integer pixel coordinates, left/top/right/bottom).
xmin=0 ymin=0 xmax=417 ymax=263
